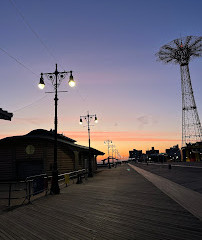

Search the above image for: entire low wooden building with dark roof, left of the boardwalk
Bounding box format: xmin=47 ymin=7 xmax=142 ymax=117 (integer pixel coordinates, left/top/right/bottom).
xmin=0 ymin=129 xmax=104 ymax=181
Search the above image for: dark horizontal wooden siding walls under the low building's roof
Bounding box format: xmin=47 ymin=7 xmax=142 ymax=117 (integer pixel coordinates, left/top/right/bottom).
xmin=0 ymin=138 xmax=96 ymax=180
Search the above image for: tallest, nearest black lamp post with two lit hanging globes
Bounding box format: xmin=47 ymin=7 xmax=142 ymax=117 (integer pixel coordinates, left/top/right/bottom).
xmin=38 ymin=64 xmax=75 ymax=194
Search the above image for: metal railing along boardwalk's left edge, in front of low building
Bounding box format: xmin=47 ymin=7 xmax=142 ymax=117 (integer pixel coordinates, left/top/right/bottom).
xmin=0 ymin=169 xmax=87 ymax=207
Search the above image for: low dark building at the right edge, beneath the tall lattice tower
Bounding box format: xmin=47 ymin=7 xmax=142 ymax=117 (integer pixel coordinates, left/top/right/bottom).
xmin=182 ymin=142 xmax=202 ymax=162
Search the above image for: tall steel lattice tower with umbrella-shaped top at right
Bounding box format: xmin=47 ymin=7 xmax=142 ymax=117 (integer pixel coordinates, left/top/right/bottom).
xmin=156 ymin=36 xmax=202 ymax=147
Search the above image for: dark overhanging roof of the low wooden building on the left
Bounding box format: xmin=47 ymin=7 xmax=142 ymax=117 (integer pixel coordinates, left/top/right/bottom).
xmin=0 ymin=129 xmax=105 ymax=155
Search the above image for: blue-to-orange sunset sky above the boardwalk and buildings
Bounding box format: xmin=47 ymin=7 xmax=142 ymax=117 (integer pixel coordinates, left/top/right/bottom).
xmin=0 ymin=0 xmax=202 ymax=161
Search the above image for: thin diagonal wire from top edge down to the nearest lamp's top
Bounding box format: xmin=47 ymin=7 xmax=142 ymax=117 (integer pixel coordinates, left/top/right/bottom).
xmin=9 ymin=0 xmax=64 ymax=70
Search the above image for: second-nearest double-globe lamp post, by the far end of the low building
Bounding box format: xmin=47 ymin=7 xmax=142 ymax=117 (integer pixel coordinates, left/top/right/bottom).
xmin=80 ymin=112 xmax=98 ymax=177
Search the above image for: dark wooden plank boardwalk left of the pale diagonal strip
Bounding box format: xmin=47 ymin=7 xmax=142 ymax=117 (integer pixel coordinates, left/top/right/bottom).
xmin=0 ymin=165 xmax=202 ymax=240
